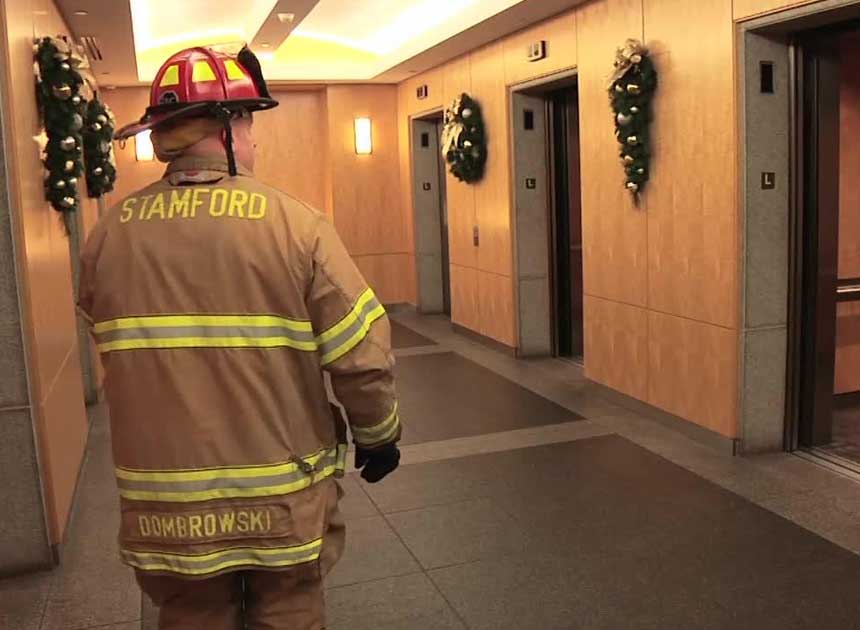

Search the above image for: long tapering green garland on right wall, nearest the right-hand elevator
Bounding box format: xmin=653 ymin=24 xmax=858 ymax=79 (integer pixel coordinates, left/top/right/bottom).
xmin=609 ymin=39 xmax=657 ymax=200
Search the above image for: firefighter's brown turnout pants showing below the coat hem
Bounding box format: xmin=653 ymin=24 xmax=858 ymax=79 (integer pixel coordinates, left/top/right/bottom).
xmin=137 ymin=570 xmax=325 ymax=630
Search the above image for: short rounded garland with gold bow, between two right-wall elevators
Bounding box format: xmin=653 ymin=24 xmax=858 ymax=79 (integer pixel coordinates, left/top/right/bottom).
xmin=442 ymin=94 xmax=487 ymax=183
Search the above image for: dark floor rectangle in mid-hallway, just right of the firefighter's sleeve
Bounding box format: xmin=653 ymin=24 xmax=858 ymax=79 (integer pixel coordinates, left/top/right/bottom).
xmin=395 ymin=352 xmax=582 ymax=444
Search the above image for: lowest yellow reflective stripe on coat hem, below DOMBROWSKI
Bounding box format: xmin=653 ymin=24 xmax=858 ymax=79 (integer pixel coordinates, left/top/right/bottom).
xmin=121 ymin=538 xmax=322 ymax=575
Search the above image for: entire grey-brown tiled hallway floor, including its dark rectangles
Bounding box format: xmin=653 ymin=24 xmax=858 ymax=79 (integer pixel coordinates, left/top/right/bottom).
xmin=0 ymin=312 xmax=860 ymax=630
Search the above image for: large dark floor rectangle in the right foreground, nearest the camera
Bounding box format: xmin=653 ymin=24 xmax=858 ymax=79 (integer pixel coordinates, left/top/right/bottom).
xmin=367 ymin=436 xmax=860 ymax=630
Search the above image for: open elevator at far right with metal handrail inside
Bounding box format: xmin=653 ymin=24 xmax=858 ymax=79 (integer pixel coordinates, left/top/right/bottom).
xmin=794 ymin=27 xmax=860 ymax=465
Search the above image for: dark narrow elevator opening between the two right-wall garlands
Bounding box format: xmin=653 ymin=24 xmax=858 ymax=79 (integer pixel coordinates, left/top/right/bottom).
xmin=548 ymin=86 xmax=583 ymax=358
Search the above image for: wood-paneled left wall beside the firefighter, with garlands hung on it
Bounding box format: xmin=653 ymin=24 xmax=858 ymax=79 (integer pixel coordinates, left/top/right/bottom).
xmin=0 ymin=0 xmax=90 ymax=543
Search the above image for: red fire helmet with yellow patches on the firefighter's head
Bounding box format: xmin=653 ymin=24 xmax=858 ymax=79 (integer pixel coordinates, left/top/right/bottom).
xmin=116 ymin=46 xmax=278 ymax=140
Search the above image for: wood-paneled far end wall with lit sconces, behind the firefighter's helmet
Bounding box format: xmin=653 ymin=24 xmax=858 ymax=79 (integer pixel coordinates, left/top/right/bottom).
xmin=104 ymin=85 xmax=415 ymax=303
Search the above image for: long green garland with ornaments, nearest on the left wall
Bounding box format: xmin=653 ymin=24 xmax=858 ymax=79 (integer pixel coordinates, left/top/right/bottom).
xmin=35 ymin=37 xmax=86 ymax=212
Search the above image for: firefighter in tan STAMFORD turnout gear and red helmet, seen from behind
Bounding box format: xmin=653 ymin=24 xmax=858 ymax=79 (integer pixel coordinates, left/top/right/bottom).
xmin=80 ymin=47 xmax=401 ymax=630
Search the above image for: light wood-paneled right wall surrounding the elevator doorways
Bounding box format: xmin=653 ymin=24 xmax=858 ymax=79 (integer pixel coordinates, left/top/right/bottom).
xmin=399 ymin=0 xmax=739 ymax=437
